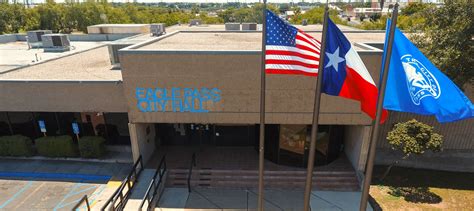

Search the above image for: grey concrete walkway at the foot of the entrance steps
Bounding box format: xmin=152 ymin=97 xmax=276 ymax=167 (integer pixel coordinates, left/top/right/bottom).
xmin=157 ymin=188 xmax=372 ymax=211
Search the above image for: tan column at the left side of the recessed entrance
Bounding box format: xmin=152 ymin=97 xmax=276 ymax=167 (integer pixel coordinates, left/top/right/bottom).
xmin=128 ymin=123 xmax=156 ymax=164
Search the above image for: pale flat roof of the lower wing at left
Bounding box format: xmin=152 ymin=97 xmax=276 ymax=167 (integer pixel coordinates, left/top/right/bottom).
xmin=0 ymin=34 xmax=153 ymax=81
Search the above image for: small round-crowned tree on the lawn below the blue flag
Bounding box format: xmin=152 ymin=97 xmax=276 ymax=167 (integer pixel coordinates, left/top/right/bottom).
xmin=381 ymin=119 xmax=443 ymax=180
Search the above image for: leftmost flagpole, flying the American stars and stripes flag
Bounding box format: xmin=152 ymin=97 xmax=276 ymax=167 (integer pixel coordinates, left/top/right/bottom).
xmin=258 ymin=0 xmax=267 ymax=211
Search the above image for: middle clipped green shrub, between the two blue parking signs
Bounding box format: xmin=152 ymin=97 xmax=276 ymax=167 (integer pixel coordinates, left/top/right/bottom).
xmin=35 ymin=136 xmax=78 ymax=157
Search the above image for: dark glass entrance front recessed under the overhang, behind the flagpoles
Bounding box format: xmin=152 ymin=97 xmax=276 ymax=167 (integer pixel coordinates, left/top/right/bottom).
xmin=155 ymin=123 xmax=344 ymax=168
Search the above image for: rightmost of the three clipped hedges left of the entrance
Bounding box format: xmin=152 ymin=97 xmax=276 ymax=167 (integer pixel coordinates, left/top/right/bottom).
xmin=79 ymin=136 xmax=105 ymax=158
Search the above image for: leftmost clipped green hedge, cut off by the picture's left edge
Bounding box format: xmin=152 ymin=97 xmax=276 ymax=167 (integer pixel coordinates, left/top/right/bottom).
xmin=0 ymin=135 xmax=33 ymax=156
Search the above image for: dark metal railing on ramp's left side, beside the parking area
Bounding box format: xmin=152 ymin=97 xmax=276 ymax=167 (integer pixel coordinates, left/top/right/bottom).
xmin=100 ymin=155 xmax=143 ymax=211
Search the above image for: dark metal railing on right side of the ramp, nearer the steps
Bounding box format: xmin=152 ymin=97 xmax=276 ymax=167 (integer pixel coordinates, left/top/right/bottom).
xmin=139 ymin=155 xmax=167 ymax=210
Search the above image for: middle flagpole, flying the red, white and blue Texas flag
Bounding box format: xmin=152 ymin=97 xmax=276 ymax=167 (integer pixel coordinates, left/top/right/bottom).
xmin=304 ymin=3 xmax=329 ymax=211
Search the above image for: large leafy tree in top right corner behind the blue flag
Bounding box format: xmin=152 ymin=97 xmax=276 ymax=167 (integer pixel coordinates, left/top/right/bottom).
xmin=412 ymin=0 xmax=474 ymax=88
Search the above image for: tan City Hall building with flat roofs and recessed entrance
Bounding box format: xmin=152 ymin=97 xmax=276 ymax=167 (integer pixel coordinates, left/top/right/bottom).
xmin=0 ymin=22 xmax=474 ymax=189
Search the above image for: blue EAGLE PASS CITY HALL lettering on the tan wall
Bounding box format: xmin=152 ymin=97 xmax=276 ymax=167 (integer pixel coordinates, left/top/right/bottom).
xmin=135 ymin=87 xmax=221 ymax=113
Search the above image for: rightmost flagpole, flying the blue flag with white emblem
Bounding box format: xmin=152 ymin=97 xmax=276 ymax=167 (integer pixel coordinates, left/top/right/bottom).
xmin=359 ymin=3 xmax=398 ymax=211
